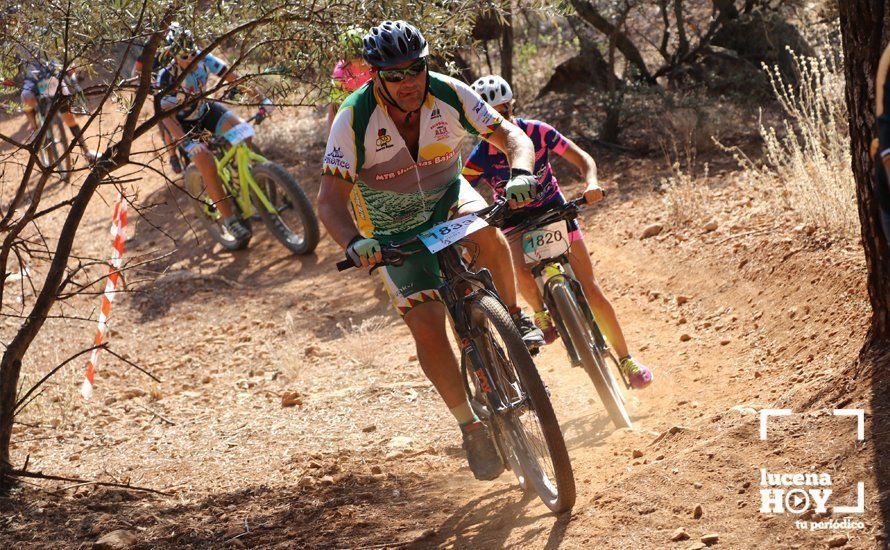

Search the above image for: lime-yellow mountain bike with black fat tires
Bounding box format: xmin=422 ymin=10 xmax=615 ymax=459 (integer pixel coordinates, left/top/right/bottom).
xmin=177 ymin=113 xmax=319 ymax=254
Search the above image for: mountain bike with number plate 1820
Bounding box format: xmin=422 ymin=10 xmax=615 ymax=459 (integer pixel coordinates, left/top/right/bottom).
xmin=505 ymin=197 xmax=631 ymax=428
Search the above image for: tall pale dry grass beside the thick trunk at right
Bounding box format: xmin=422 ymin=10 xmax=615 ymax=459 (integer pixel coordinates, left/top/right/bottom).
xmin=732 ymin=48 xmax=857 ymax=236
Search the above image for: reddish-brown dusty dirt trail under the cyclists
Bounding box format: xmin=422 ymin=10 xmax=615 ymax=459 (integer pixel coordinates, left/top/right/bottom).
xmin=0 ymin=109 xmax=875 ymax=548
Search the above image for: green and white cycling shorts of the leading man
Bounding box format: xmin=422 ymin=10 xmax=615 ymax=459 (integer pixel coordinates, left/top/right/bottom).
xmin=378 ymin=178 xmax=487 ymax=317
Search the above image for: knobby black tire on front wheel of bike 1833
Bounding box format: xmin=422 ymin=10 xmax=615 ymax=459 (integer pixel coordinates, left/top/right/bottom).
xmin=468 ymin=295 xmax=575 ymax=513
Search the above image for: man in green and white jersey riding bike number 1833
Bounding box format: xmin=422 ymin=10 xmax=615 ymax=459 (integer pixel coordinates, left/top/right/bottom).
xmin=318 ymin=21 xmax=543 ymax=479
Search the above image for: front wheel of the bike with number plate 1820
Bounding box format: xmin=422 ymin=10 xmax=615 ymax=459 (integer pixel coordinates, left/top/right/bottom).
xmin=549 ymin=280 xmax=631 ymax=428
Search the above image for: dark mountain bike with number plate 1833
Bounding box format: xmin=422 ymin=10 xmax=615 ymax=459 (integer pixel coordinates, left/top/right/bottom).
xmin=337 ymin=202 xmax=575 ymax=513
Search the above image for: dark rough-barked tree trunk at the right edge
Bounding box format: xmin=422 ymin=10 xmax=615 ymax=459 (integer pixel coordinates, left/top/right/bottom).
xmin=839 ymin=0 xmax=890 ymax=351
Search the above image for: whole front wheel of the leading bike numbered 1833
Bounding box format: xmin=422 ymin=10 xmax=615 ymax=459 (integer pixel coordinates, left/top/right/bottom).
xmin=468 ymin=295 xmax=575 ymax=513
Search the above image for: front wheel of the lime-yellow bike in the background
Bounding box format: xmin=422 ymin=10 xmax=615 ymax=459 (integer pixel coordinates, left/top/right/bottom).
xmin=250 ymin=162 xmax=319 ymax=254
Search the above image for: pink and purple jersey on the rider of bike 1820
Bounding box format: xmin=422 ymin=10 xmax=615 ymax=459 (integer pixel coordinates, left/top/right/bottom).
xmin=463 ymin=118 xmax=568 ymax=208
